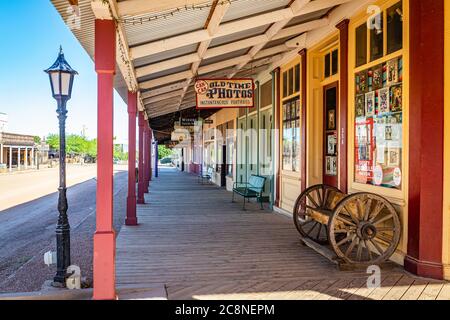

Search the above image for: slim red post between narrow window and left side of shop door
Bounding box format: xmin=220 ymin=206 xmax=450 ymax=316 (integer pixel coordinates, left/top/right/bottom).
xmin=299 ymin=49 xmax=307 ymax=192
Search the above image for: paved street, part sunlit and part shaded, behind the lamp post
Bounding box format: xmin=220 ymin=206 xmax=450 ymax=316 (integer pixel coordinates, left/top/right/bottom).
xmin=0 ymin=165 xmax=127 ymax=292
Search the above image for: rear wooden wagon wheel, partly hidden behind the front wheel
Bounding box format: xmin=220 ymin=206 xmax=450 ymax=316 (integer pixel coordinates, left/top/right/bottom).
xmin=294 ymin=185 xmax=341 ymax=244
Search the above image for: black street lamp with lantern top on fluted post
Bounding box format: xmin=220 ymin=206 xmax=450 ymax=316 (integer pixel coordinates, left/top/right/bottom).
xmin=45 ymin=47 xmax=78 ymax=287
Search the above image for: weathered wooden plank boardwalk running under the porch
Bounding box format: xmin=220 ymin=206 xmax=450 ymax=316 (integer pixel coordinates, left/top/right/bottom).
xmin=116 ymin=168 xmax=450 ymax=300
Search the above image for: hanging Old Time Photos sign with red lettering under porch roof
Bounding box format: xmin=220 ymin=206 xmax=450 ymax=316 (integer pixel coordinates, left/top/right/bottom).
xmin=195 ymin=78 xmax=255 ymax=109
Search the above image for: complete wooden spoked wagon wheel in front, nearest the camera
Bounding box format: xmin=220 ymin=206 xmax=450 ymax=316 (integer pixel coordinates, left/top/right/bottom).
xmin=328 ymin=193 xmax=401 ymax=265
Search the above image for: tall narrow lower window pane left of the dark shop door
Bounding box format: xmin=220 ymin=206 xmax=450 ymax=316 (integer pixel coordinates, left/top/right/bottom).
xmin=283 ymin=98 xmax=300 ymax=172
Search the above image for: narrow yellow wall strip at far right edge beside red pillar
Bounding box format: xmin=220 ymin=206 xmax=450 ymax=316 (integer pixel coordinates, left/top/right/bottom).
xmin=442 ymin=0 xmax=450 ymax=280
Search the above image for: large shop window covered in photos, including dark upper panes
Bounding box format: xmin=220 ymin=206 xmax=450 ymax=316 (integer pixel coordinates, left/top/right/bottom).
xmin=354 ymin=2 xmax=404 ymax=189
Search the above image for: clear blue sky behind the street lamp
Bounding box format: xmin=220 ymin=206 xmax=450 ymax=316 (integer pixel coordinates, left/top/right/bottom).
xmin=0 ymin=0 xmax=128 ymax=140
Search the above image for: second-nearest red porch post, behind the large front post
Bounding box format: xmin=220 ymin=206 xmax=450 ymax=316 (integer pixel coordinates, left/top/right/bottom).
xmin=125 ymin=92 xmax=138 ymax=226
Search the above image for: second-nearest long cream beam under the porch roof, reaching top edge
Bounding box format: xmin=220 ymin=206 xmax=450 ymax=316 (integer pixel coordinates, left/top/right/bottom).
xmin=131 ymin=0 xmax=353 ymax=59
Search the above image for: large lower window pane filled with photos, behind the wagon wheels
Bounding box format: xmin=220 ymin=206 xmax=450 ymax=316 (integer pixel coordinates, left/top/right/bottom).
xmin=354 ymin=57 xmax=403 ymax=189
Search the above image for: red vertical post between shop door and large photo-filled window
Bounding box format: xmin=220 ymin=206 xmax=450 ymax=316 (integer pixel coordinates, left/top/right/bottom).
xmin=336 ymin=19 xmax=349 ymax=193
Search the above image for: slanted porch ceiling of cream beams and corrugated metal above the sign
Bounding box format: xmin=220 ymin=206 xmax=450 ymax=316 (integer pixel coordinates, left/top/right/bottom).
xmin=93 ymin=0 xmax=357 ymax=118
